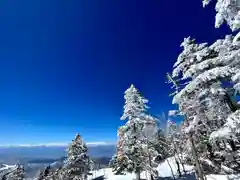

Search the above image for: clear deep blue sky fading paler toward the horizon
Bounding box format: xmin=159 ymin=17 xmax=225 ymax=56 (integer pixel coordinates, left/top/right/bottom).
xmin=0 ymin=0 xmax=228 ymax=144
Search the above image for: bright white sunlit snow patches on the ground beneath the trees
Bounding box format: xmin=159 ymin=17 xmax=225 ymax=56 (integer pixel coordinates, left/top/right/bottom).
xmin=88 ymin=157 xmax=240 ymax=180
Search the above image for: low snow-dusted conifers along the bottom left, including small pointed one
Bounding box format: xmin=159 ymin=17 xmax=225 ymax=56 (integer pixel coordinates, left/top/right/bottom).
xmin=1 ymin=134 xmax=93 ymax=180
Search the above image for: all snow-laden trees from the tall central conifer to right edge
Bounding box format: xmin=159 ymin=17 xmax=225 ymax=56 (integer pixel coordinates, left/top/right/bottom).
xmin=110 ymin=0 xmax=240 ymax=180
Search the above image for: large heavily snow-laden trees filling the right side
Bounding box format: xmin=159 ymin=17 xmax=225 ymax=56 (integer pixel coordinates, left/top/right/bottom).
xmin=167 ymin=0 xmax=240 ymax=180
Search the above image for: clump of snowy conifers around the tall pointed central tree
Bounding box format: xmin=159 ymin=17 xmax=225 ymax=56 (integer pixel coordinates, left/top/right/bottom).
xmin=110 ymin=85 xmax=172 ymax=180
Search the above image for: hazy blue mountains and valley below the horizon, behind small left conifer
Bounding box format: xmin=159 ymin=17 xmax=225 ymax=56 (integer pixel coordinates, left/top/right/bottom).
xmin=0 ymin=143 xmax=116 ymax=177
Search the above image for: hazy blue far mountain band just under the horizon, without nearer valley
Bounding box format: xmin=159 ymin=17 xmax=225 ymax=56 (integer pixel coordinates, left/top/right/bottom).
xmin=0 ymin=143 xmax=116 ymax=164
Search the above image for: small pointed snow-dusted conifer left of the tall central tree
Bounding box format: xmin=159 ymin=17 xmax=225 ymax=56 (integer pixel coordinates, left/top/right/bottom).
xmin=67 ymin=134 xmax=91 ymax=180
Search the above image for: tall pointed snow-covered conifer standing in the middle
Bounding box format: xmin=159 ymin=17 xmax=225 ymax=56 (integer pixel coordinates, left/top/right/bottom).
xmin=118 ymin=85 xmax=158 ymax=180
